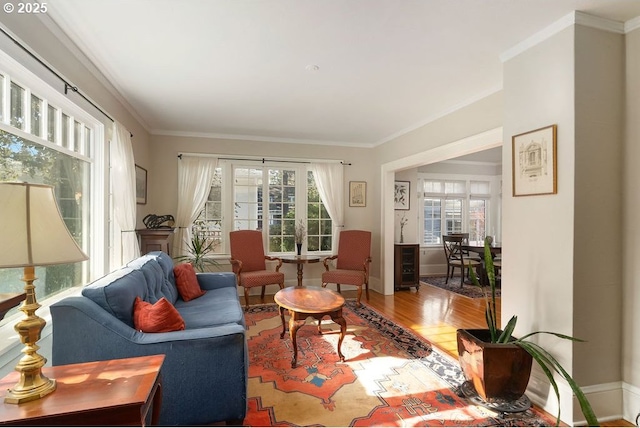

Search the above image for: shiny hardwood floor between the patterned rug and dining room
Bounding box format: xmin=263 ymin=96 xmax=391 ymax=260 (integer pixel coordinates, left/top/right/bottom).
xmin=249 ymin=284 xmax=635 ymax=427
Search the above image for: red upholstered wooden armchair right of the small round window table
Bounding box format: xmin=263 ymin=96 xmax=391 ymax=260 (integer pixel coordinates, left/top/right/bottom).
xmin=322 ymin=230 xmax=371 ymax=306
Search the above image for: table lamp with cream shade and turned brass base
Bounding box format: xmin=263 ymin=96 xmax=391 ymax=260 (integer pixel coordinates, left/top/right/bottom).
xmin=0 ymin=183 xmax=88 ymax=404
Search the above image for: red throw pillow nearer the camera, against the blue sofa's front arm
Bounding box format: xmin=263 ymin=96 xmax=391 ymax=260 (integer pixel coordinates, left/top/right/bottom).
xmin=133 ymin=297 xmax=185 ymax=333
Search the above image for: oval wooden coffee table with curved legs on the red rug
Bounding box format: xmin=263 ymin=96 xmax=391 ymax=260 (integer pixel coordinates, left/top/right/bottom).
xmin=274 ymin=287 xmax=347 ymax=368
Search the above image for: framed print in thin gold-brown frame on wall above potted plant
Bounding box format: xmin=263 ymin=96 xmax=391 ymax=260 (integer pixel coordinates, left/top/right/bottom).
xmin=511 ymin=125 xmax=558 ymax=196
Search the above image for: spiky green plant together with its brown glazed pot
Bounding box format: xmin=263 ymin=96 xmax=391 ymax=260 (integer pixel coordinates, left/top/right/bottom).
xmin=457 ymin=239 xmax=598 ymax=426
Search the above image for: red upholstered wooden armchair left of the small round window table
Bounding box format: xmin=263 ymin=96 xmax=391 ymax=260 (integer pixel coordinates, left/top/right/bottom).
xmin=229 ymin=230 xmax=284 ymax=310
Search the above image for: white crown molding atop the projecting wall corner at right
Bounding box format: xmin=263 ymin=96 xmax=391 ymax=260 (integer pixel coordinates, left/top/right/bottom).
xmin=500 ymin=10 xmax=626 ymax=62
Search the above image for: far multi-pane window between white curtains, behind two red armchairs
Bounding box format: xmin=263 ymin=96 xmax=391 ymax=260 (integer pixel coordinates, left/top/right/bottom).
xmin=192 ymin=160 xmax=333 ymax=254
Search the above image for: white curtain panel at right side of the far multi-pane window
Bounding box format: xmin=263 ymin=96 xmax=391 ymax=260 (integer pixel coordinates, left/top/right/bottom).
xmin=311 ymin=163 xmax=344 ymax=252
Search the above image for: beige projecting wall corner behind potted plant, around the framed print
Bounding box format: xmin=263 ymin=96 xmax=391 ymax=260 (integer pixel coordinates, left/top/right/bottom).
xmin=502 ymin=18 xmax=624 ymax=423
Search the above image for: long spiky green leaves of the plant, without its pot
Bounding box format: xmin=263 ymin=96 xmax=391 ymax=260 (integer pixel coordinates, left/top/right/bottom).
xmin=469 ymin=239 xmax=599 ymax=426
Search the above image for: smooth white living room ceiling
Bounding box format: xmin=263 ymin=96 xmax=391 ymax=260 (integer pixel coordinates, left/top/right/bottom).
xmin=48 ymin=0 xmax=640 ymax=147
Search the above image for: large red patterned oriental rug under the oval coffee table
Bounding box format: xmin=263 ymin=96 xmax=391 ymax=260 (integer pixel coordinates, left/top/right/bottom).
xmin=243 ymin=300 xmax=555 ymax=427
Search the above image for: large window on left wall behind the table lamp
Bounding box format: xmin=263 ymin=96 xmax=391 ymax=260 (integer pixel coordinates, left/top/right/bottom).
xmin=0 ymin=52 xmax=105 ymax=324
